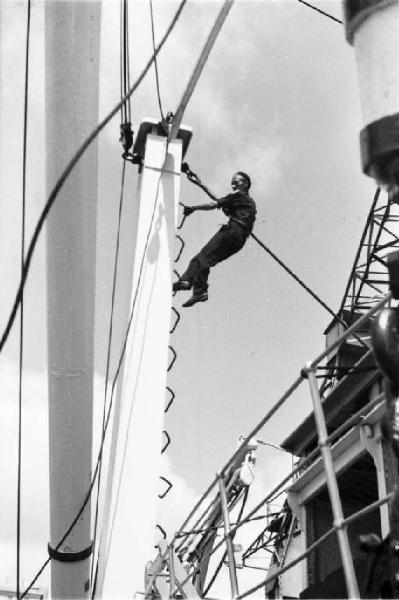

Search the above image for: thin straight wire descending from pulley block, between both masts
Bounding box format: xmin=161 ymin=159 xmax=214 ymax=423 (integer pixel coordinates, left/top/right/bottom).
xmin=90 ymin=161 xmax=126 ymax=596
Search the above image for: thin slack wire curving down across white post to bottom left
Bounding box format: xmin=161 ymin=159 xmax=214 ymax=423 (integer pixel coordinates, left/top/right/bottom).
xmin=21 ymin=141 xmax=169 ymax=600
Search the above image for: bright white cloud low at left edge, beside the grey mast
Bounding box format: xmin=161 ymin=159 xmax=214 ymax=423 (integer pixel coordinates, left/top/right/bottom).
xmin=0 ymin=360 xmax=49 ymax=580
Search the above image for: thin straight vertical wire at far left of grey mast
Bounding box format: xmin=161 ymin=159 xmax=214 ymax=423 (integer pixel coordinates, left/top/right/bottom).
xmin=16 ymin=0 xmax=31 ymax=600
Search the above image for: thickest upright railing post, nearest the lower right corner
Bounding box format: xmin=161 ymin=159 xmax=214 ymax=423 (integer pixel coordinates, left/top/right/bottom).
xmin=305 ymin=366 xmax=360 ymax=598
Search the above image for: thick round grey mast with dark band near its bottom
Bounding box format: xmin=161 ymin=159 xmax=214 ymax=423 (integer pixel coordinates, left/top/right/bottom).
xmin=45 ymin=0 xmax=101 ymax=598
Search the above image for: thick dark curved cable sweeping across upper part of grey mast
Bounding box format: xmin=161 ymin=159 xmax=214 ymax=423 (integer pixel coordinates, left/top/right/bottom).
xmin=0 ymin=0 xmax=187 ymax=352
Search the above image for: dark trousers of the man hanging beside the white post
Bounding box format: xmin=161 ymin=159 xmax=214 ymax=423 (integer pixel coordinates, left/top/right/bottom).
xmin=180 ymin=223 xmax=248 ymax=294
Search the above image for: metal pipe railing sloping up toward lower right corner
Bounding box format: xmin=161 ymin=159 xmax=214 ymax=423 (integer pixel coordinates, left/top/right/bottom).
xmin=145 ymin=294 xmax=392 ymax=600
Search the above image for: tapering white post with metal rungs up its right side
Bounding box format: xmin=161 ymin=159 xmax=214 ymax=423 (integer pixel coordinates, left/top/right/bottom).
xmin=96 ymin=122 xmax=190 ymax=599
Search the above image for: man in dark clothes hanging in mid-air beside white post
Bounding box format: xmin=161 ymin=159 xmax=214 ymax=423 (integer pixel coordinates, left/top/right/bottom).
xmin=173 ymin=165 xmax=256 ymax=307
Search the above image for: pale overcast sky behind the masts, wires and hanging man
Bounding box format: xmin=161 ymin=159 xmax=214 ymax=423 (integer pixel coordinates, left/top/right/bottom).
xmin=0 ymin=0 xmax=382 ymax=596
